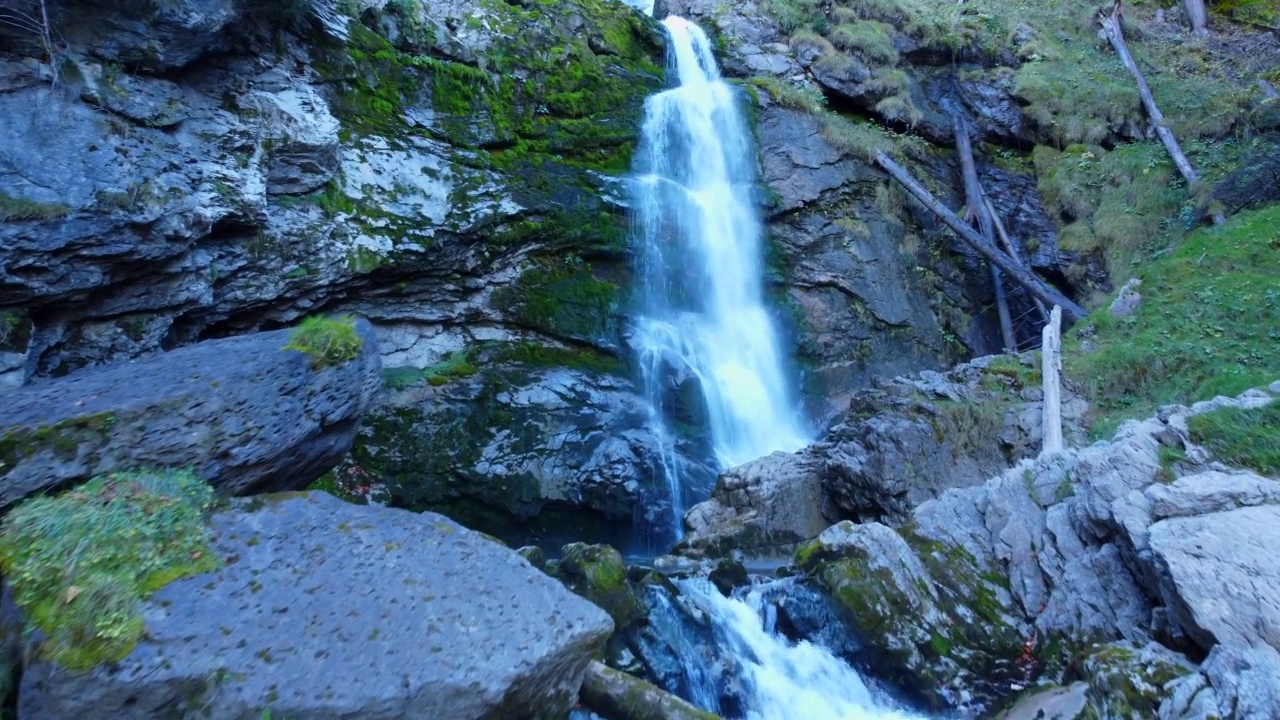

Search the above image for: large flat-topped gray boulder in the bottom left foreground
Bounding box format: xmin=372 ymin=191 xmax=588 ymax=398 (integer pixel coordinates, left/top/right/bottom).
xmin=18 ymin=492 xmax=613 ymax=720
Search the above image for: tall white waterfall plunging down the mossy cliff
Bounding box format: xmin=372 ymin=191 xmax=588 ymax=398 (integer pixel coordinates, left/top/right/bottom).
xmin=631 ymin=17 xmax=809 ymax=536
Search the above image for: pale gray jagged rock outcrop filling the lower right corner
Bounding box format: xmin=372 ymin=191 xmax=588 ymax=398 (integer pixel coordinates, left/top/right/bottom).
xmin=797 ymin=391 xmax=1280 ymax=720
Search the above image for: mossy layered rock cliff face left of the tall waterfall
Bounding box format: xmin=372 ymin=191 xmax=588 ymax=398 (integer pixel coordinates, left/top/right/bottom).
xmin=0 ymin=0 xmax=708 ymax=537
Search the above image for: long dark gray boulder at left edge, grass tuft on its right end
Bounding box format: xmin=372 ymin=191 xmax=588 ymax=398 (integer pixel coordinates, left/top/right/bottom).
xmin=0 ymin=320 xmax=381 ymax=510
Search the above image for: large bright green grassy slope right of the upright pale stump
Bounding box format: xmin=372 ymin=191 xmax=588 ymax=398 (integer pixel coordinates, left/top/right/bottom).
xmin=1064 ymin=206 xmax=1280 ymax=437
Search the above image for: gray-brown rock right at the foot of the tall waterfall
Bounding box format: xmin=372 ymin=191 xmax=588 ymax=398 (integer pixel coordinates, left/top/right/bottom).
xmin=676 ymin=452 xmax=837 ymax=557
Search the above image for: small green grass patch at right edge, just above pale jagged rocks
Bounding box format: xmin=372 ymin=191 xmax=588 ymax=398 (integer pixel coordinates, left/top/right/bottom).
xmin=1187 ymin=402 xmax=1280 ymax=478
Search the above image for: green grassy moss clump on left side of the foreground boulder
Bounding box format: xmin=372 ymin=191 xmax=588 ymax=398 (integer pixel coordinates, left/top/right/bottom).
xmin=0 ymin=470 xmax=218 ymax=670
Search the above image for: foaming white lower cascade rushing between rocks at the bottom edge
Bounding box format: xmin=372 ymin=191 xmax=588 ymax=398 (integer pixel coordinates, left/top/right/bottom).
xmin=676 ymin=579 xmax=924 ymax=720
